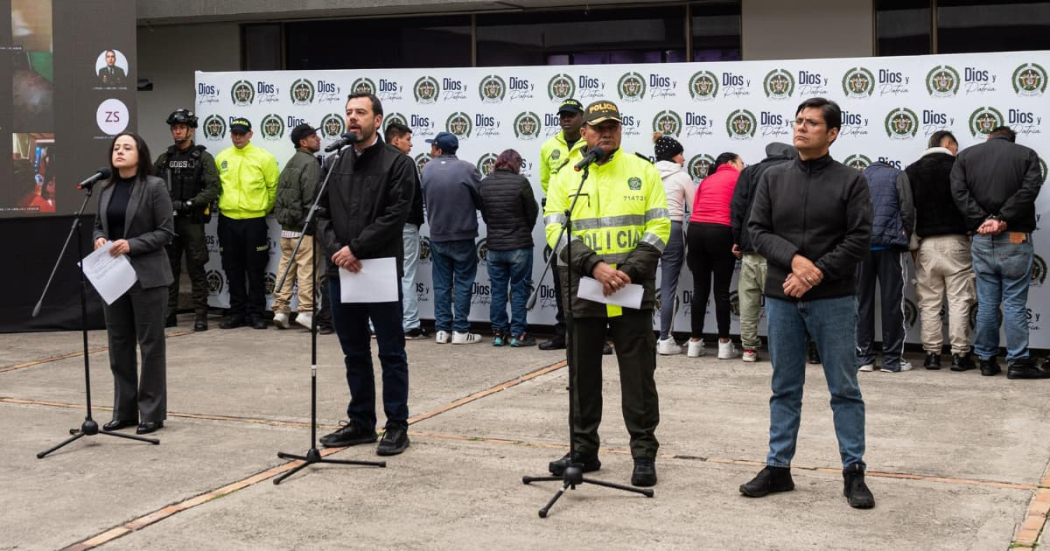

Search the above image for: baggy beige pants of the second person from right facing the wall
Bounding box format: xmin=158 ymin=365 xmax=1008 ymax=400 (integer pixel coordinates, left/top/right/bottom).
xmin=916 ymin=235 xmax=977 ymax=354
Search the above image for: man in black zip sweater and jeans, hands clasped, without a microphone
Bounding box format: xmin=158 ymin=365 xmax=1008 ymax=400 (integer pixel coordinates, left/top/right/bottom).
xmin=740 ymin=98 xmax=875 ymax=509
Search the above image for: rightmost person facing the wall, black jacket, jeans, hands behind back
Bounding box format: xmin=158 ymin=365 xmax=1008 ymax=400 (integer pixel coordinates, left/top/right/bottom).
xmin=951 ymin=126 xmax=1050 ymax=379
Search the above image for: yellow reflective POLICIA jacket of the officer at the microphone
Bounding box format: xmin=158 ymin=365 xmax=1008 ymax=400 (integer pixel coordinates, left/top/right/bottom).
xmin=544 ymin=150 xmax=671 ymax=317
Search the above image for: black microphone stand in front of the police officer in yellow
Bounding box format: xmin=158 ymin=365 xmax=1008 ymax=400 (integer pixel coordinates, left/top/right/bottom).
xmin=522 ymin=158 xmax=653 ymax=518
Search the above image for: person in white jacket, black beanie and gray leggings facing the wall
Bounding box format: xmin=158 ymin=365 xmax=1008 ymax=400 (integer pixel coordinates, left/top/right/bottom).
xmin=653 ymin=132 xmax=696 ymax=355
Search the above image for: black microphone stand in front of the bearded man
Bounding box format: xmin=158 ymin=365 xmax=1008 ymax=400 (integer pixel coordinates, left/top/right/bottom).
xmin=273 ymin=143 xmax=386 ymax=484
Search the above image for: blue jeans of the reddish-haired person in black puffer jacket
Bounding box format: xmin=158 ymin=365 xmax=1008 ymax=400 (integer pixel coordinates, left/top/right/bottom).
xmin=488 ymin=248 xmax=532 ymax=337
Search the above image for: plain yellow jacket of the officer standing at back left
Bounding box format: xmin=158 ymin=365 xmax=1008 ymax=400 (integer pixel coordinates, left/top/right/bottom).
xmin=215 ymin=143 xmax=280 ymax=219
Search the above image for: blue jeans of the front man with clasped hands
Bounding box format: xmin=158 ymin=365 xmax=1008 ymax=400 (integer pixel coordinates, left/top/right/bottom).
xmin=765 ymin=296 xmax=864 ymax=467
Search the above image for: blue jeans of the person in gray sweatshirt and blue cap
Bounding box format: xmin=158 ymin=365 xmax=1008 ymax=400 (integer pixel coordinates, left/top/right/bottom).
xmin=431 ymin=239 xmax=478 ymax=333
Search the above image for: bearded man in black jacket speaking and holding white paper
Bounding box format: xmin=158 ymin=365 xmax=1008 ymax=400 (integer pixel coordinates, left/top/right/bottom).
xmin=317 ymin=93 xmax=416 ymax=455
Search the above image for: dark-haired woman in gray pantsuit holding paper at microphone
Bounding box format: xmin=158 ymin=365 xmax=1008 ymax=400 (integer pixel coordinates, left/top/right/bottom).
xmin=93 ymin=132 xmax=174 ymax=435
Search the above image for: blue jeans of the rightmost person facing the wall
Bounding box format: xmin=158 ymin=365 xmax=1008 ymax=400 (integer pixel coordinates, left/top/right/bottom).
xmin=970 ymin=233 xmax=1032 ymax=364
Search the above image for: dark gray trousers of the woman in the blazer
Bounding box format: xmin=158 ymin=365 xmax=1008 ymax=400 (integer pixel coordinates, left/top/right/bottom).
xmin=102 ymin=283 xmax=168 ymax=423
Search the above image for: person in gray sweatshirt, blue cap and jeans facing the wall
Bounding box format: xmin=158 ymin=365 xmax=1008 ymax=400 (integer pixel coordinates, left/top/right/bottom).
xmin=422 ymin=132 xmax=481 ymax=344
